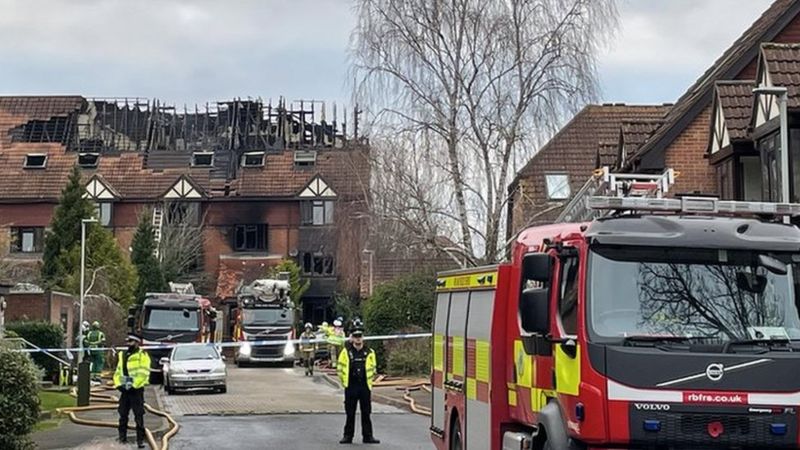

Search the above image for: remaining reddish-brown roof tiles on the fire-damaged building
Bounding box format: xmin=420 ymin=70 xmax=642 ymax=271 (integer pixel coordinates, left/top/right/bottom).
xmin=0 ymin=96 xmax=370 ymax=201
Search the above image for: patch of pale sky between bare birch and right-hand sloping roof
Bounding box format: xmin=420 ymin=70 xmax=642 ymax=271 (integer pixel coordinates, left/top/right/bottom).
xmin=599 ymin=0 xmax=772 ymax=103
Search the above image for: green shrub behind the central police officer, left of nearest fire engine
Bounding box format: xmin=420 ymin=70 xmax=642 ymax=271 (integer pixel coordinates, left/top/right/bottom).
xmin=362 ymin=274 xmax=436 ymax=370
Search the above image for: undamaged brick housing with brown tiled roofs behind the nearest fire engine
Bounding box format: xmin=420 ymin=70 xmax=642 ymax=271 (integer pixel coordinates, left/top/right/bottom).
xmin=508 ymin=0 xmax=800 ymax=237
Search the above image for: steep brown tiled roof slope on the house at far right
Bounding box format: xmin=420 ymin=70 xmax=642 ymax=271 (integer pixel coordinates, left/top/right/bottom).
xmin=637 ymin=0 xmax=800 ymax=168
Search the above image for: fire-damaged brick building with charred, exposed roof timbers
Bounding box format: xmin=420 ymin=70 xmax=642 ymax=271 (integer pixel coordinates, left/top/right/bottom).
xmin=0 ymin=96 xmax=370 ymax=321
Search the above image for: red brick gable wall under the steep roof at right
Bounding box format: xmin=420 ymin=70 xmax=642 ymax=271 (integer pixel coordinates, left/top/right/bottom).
xmin=665 ymin=106 xmax=717 ymax=194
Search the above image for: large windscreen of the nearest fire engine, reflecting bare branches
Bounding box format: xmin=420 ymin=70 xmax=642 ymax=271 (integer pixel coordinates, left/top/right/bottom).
xmin=587 ymin=246 xmax=800 ymax=344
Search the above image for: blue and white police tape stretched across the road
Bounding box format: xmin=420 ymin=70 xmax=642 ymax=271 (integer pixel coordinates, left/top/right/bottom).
xmin=11 ymin=333 xmax=432 ymax=353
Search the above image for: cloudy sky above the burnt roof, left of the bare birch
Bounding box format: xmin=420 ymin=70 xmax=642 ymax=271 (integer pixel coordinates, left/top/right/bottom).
xmin=0 ymin=0 xmax=355 ymax=104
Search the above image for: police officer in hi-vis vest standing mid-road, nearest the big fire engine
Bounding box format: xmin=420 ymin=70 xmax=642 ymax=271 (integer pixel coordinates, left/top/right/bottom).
xmin=338 ymin=328 xmax=381 ymax=444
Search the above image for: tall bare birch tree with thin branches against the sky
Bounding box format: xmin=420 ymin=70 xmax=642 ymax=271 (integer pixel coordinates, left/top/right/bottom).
xmin=352 ymin=0 xmax=616 ymax=262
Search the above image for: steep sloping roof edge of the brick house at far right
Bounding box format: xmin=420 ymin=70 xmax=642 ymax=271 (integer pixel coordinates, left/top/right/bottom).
xmin=636 ymin=0 xmax=800 ymax=169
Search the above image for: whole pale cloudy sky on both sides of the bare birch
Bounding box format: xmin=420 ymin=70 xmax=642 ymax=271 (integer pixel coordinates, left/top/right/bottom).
xmin=0 ymin=0 xmax=771 ymax=106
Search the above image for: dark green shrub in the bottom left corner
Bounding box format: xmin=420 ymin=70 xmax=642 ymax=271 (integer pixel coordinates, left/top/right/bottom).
xmin=0 ymin=347 xmax=39 ymax=450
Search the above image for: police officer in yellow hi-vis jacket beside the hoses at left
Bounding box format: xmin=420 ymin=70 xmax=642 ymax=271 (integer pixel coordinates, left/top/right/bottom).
xmin=114 ymin=334 xmax=150 ymax=448
